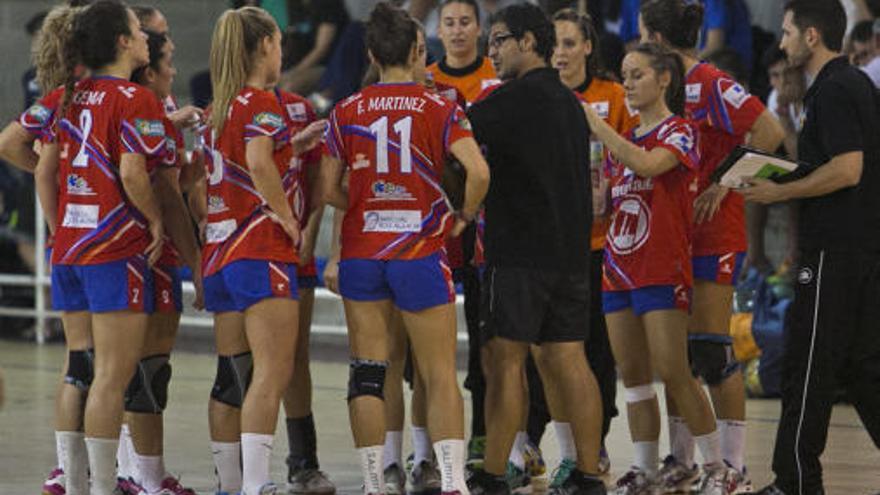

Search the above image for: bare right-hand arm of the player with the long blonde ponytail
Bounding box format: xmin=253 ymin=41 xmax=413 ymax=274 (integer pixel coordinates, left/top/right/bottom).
xmin=245 ymin=136 xmax=300 ymax=244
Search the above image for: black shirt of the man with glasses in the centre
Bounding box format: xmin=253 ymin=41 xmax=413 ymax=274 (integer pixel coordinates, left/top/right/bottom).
xmin=468 ymin=68 xmax=592 ymax=271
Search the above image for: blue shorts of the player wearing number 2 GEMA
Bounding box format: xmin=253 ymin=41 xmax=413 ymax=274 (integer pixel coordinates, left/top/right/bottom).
xmin=52 ymin=255 xmax=154 ymax=313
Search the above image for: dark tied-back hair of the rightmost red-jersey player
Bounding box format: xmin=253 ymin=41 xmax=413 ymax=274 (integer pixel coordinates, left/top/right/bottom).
xmin=639 ymin=0 xmax=704 ymax=50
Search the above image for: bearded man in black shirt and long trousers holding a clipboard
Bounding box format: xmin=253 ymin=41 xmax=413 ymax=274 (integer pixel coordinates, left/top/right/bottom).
xmin=744 ymin=0 xmax=880 ymax=495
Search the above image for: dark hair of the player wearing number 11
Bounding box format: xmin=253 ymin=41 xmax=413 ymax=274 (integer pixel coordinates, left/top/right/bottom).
xmin=365 ymin=2 xmax=418 ymax=67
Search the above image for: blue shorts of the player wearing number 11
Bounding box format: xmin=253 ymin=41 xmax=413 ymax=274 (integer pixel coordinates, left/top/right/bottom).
xmin=339 ymin=253 xmax=455 ymax=311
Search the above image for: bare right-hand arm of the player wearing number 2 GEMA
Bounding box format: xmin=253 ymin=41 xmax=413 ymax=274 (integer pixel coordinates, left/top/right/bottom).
xmin=119 ymin=153 xmax=164 ymax=265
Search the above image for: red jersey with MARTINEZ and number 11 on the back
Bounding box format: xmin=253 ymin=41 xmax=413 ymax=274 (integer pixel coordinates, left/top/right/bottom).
xmin=326 ymin=83 xmax=473 ymax=260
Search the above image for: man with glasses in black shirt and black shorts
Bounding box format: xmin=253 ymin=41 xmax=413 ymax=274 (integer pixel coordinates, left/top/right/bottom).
xmin=469 ymin=4 xmax=605 ymax=495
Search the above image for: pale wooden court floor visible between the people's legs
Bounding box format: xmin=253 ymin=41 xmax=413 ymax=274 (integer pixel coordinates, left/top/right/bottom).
xmin=0 ymin=341 xmax=880 ymax=495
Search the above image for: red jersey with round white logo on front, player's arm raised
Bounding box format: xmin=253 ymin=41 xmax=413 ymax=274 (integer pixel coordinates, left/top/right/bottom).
xmin=602 ymin=115 xmax=700 ymax=291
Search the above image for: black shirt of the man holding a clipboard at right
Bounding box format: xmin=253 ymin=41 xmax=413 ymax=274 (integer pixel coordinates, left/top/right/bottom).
xmin=798 ymin=57 xmax=880 ymax=251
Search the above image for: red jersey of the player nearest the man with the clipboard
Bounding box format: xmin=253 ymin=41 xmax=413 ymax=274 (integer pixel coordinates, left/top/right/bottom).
xmin=685 ymin=63 xmax=764 ymax=256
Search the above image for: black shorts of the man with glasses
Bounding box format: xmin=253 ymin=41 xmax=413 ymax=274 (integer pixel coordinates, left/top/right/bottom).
xmin=480 ymin=266 xmax=590 ymax=344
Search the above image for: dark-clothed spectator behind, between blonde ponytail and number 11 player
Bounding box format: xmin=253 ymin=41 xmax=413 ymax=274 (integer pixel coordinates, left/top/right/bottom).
xmin=281 ymin=0 xmax=349 ymax=95
